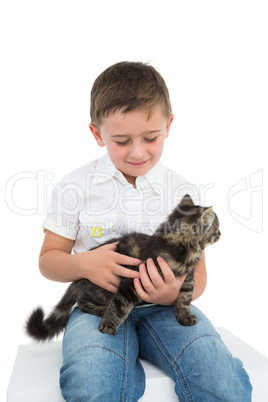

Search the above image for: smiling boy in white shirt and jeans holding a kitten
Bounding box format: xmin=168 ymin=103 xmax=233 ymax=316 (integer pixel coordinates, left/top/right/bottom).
xmin=40 ymin=62 xmax=251 ymax=402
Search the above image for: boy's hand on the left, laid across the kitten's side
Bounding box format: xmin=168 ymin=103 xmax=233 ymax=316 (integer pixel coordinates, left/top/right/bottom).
xmin=80 ymin=242 xmax=141 ymax=293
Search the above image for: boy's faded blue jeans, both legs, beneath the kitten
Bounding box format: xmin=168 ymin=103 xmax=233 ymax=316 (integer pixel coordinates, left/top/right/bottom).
xmin=60 ymin=305 xmax=252 ymax=402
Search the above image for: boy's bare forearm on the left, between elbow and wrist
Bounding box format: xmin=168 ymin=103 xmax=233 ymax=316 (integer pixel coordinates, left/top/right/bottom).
xmin=39 ymin=250 xmax=83 ymax=282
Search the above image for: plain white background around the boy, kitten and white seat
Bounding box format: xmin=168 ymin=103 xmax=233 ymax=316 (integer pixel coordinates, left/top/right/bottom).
xmin=0 ymin=0 xmax=268 ymax=400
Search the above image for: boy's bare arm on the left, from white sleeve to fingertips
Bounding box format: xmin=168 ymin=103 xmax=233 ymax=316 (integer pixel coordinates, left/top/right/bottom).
xmin=39 ymin=231 xmax=141 ymax=293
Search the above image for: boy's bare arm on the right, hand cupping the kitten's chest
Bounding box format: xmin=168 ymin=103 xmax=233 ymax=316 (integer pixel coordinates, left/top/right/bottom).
xmin=134 ymin=251 xmax=207 ymax=305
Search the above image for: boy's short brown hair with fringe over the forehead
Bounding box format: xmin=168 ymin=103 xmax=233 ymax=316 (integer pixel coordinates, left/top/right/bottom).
xmin=90 ymin=61 xmax=172 ymax=127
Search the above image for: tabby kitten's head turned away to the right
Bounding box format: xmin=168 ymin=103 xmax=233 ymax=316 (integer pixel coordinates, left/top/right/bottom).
xmin=162 ymin=195 xmax=221 ymax=249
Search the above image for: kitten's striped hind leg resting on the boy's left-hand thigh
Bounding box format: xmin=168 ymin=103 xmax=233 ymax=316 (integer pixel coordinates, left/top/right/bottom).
xmin=99 ymin=279 xmax=140 ymax=335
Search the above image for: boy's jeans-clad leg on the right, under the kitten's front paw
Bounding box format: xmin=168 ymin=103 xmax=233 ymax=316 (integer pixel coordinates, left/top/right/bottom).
xmin=135 ymin=306 xmax=252 ymax=402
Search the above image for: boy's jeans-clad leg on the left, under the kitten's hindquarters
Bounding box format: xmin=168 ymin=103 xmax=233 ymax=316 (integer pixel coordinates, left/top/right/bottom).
xmin=60 ymin=308 xmax=145 ymax=402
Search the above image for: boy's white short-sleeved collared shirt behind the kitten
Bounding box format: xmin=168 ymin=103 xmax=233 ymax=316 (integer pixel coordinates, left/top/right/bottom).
xmin=43 ymin=154 xmax=198 ymax=253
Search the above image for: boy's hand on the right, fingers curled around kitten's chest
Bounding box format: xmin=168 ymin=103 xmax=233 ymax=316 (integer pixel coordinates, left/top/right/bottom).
xmin=134 ymin=257 xmax=186 ymax=306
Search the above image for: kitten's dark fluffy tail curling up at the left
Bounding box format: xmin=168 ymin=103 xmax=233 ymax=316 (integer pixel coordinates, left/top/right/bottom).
xmin=25 ymin=285 xmax=76 ymax=341
